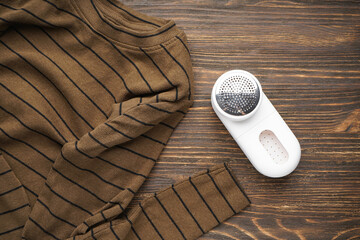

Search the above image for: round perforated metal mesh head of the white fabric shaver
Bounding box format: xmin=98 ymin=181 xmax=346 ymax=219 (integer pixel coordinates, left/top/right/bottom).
xmin=215 ymin=74 xmax=260 ymax=116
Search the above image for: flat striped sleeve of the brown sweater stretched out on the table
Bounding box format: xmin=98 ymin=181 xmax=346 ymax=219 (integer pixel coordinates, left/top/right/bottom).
xmin=67 ymin=163 xmax=250 ymax=240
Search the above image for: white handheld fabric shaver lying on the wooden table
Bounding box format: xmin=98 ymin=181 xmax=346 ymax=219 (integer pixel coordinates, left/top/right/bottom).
xmin=211 ymin=70 xmax=301 ymax=178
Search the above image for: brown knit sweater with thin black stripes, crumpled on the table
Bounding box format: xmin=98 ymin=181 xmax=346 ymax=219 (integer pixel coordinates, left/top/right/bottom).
xmin=0 ymin=0 xmax=249 ymax=240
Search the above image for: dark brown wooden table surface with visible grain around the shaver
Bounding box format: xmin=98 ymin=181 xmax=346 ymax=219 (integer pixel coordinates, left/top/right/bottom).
xmin=123 ymin=0 xmax=360 ymax=240
